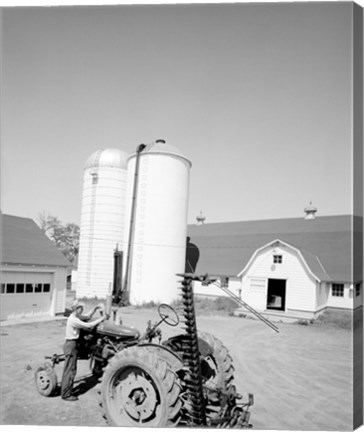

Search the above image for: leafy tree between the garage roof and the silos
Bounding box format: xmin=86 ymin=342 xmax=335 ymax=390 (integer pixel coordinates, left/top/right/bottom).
xmin=38 ymin=210 xmax=80 ymax=263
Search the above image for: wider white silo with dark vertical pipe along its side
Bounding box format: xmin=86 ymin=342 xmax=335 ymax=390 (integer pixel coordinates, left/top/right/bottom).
xmin=123 ymin=140 xmax=191 ymax=304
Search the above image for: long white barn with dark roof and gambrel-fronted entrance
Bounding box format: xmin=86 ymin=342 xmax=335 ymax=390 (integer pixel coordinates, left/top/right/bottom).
xmin=186 ymin=215 xmax=363 ymax=319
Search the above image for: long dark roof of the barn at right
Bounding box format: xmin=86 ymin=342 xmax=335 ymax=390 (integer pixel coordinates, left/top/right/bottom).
xmin=187 ymin=215 xmax=363 ymax=282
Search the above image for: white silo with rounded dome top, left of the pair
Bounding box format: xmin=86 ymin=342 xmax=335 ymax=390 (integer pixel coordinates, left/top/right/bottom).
xmin=76 ymin=149 xmax=128 ymax=298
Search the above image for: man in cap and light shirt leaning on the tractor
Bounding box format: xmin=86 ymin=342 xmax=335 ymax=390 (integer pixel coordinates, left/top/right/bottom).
xmin=61 ymin=300 xmax=106 ymax=401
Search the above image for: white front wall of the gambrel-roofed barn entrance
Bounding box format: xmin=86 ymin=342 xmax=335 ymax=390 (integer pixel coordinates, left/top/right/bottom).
xmin=242 ymin=244 xmax=316 ymax=312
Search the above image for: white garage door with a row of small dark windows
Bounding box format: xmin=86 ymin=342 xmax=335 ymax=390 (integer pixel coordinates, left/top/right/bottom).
xmin=1 ymin=271 xmax=53 ymax=320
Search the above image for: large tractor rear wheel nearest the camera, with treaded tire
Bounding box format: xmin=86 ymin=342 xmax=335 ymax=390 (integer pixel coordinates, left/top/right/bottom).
xmin=100 ymin=346 xmax=182 ymax=427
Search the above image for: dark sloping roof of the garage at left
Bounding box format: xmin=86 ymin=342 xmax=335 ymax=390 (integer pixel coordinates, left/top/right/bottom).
xmin=0 ymin=214 xmax=71 ymax=267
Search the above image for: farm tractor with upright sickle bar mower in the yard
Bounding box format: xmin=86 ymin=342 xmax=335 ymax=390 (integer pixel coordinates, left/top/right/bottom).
xmin=35 ymin=274 xmax=278 ymax=428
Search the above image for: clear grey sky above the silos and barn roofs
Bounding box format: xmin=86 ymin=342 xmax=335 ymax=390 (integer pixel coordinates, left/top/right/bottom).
xmin=1 ymin=2 xmax=362 ymax=224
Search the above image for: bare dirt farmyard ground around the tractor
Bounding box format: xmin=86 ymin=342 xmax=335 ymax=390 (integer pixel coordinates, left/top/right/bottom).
xmin=0 ymin=308 xmax=362 ymax=431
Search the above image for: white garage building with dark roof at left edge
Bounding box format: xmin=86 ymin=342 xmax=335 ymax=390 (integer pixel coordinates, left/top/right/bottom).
xmin=0 ymin=214 xmax=70 ymax=320
